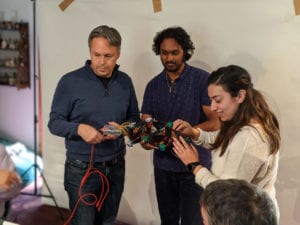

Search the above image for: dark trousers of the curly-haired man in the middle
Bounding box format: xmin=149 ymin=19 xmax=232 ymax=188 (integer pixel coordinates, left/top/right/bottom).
xmin=154 ymin=168 xmax=203 ymax=225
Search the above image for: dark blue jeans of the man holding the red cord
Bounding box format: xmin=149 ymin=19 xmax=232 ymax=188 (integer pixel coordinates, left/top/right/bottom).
xmin=64 ymin=159 xmax=125 ymax=225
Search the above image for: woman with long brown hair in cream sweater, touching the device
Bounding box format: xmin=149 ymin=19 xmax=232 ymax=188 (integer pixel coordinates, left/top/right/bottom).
xmin=173 ymin=65 xmax=280 ymax=217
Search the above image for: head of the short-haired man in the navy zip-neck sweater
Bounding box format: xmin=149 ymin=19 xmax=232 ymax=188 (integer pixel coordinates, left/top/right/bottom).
xmin=88 ymin=25 xmax=122 ymax=78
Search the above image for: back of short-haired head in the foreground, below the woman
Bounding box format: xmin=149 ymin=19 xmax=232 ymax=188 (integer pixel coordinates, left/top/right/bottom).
xmin=200 ymin=179 xmax=278 ymax=225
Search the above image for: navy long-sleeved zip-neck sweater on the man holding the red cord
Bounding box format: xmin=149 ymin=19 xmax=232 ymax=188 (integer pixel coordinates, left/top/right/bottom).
xmin=48 ymin=60 xmax=139 ymax=162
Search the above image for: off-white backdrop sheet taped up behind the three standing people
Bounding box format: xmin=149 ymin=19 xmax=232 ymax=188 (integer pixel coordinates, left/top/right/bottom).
xmin=37 ymin=0 xmax=300 ymax=225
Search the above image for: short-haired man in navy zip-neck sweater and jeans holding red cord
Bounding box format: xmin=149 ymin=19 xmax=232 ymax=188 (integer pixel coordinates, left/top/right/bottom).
xmin=48 ymin=25 xmax=139 ymax=225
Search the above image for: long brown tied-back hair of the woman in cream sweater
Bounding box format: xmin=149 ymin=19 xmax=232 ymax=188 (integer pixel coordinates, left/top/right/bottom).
xmin=208 ymin=65 xmax=280 ymax=156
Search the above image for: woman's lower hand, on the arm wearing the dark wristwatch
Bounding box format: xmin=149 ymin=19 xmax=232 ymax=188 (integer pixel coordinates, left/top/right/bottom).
xmin=173 ymin=136 xmax=199 ymax=165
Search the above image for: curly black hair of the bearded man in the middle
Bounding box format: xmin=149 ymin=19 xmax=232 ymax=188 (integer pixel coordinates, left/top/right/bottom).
xmin=152 ymin=27 xmax=195 ymax=61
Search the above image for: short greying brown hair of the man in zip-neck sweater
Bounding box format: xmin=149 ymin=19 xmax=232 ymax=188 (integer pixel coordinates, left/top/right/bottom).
xmin=88 ymin=25 xmax=122 ymax=50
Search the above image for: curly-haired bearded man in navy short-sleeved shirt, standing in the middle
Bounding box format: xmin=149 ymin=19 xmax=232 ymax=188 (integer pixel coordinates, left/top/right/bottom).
xmin=141 ymin=27 xmax=219 ymax=225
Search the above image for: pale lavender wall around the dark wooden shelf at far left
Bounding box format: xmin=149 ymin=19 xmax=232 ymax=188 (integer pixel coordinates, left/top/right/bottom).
xmin=0 ymin=0 xmax=34 ymax=148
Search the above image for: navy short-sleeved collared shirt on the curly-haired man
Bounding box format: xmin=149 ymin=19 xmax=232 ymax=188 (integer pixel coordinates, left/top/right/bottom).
xmin=141 ymin=64 xmax=210 ymax=172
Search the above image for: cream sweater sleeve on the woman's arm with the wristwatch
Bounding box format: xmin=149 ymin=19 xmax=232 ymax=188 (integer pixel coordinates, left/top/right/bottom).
xmin=195 ymin=126 xmax=269 ymax=188
